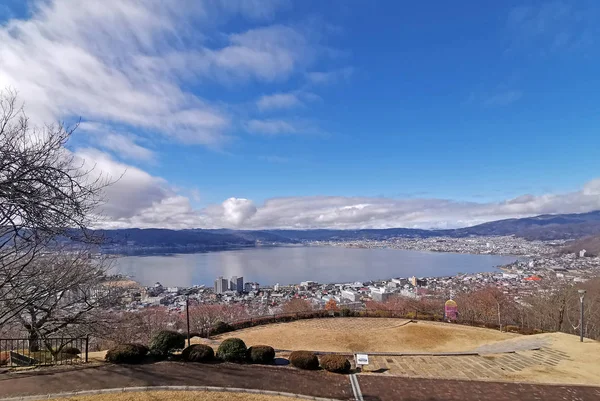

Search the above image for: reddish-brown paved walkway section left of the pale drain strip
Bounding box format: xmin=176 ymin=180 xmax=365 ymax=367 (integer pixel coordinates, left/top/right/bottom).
xmin=0 ymin=362 xmax=352 ymax=400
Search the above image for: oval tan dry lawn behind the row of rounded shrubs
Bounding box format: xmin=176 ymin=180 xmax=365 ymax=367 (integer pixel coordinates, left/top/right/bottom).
xmin=203 ymin=318 xmax=518 ymax=352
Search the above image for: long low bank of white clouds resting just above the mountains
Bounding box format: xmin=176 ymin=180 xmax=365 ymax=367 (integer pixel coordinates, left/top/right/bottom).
xmin=85 ymin=177 xmax=600 ymax=229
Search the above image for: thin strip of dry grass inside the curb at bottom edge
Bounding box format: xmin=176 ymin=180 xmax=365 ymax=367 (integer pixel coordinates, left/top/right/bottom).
xmin=52 ymin=391 xmax=300 ymax=401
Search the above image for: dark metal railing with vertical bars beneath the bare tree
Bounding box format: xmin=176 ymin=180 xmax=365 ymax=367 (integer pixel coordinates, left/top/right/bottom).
xmin=0 ymin=337 xmax=89 ymax=368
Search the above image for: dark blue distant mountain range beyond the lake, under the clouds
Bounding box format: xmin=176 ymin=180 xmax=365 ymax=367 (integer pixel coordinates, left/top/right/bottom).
xmin=91 ymin=211 xmax=600 ymax=249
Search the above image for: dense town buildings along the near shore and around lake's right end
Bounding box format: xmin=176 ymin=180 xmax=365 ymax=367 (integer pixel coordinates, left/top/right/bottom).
xmin=118 ymin=237 xmax=600 ymax=314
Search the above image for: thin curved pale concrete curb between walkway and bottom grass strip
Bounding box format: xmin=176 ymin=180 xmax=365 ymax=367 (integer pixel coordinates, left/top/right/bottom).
xmin=0 ymin=386 xmax=339 ymax=401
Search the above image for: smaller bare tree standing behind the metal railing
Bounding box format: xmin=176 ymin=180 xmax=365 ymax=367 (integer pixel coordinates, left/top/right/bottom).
xmin=8 ymin=250 xmax=126 ymax=354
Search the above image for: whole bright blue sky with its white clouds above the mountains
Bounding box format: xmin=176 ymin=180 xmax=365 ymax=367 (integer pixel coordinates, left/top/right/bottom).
xmin=0 ymin=0 xmax=600 ymax=228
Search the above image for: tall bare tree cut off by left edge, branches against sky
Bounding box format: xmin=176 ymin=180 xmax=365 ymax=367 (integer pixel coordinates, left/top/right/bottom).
xmin=0 ymin=90 xmax=108 ymax=326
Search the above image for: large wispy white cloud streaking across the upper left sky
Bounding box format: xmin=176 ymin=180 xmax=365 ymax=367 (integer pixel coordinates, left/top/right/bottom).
xmin=0 ymin=0 xmax=318 ymax=150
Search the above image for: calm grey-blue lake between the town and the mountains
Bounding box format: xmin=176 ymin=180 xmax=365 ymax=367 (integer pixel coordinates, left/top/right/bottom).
xmin=109 ymin=246 xmax=517 ymax=287
